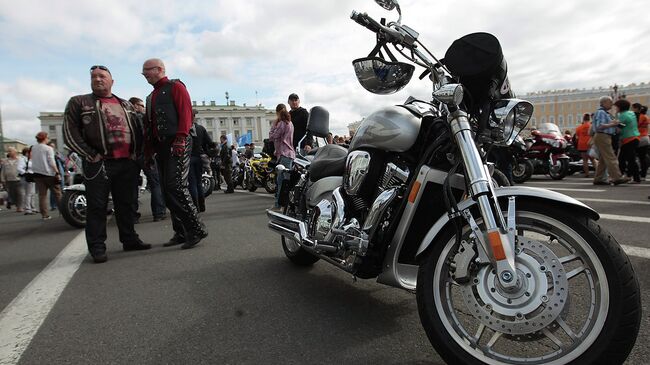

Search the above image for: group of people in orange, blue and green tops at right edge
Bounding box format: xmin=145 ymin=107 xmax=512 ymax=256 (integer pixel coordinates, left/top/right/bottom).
xmin=574 ymin=96 xmax=650 ymax=185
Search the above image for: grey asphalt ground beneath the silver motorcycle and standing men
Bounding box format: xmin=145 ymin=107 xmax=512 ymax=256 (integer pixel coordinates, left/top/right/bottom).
xmin=0 ymin=176 xmax=650 ymax=364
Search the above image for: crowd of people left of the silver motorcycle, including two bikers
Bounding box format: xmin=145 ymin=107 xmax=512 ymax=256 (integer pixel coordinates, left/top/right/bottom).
xmin=0 ymin=58 xmax=349 ymax=263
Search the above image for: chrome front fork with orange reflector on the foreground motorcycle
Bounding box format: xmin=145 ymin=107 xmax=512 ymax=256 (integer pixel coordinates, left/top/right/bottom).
xmin=448 ymin=110 xmax=517 ymax=290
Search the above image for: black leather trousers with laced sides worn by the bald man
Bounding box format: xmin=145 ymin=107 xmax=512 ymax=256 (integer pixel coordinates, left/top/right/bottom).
xmin=155 ymin=137 xmax=205 ymax=237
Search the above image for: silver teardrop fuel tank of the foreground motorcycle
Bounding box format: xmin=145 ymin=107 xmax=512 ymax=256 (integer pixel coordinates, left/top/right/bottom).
xmin=350 ymin=106 xmax=422 ymax=152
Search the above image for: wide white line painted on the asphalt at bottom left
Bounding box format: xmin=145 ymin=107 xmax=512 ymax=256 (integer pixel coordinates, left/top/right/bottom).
xmin=0 ymin=231 xmax=88 ymax=365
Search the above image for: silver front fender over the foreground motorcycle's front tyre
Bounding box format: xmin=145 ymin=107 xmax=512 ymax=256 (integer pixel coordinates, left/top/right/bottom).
xmin=415 ymin=186 xmax=600 ymax=257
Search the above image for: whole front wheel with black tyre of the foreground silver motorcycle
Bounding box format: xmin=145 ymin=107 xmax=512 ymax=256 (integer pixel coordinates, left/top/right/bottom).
xmin=416 ymin=201 xmax=641 ymax=365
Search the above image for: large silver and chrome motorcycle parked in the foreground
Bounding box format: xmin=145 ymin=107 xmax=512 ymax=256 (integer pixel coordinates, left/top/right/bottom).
xmin=267 ymin=0 xmax=641 ymax=364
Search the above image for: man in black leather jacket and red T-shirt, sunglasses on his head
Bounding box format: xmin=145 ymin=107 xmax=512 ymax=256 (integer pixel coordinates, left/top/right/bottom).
xmin=63 ymin=66 xmax=151 ymax=263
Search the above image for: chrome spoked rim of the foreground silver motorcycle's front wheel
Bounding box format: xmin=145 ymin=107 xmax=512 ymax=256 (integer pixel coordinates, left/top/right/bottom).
xmin=433 ymin=212 xmax=609 ymax=364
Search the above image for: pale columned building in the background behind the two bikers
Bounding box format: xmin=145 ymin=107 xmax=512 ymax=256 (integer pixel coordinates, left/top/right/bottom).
xmin=38 ymin=100 xmax=275 ymax=153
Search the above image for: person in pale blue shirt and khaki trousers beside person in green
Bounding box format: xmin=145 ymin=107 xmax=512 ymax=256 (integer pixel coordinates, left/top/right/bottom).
xmin=592 ymin=96 xmax=630 ymax=185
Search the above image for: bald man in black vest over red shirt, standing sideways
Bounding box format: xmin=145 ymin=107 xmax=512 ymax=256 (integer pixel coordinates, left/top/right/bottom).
xmin=142 ymin=58 xmax=208 ymax=249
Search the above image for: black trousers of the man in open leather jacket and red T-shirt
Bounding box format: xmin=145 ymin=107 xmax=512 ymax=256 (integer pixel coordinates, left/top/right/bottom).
xmin=83 ymin=158 xmax=140 ymax=255
